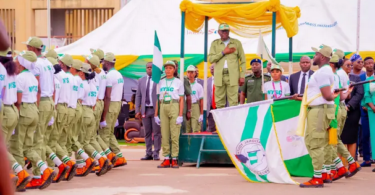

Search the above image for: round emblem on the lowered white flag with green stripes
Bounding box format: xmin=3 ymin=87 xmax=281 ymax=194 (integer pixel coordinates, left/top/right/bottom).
xmin=235 ymin=138 xmax=270 ymax=175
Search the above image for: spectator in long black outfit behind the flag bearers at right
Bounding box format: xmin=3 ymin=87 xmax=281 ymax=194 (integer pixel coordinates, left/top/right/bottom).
xmin=341 ymin=59 xmax=363 ymax=161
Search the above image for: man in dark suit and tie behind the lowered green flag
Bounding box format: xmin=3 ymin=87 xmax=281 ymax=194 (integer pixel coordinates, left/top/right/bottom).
xmin=289 ymin=56 xmax=314 ymax=95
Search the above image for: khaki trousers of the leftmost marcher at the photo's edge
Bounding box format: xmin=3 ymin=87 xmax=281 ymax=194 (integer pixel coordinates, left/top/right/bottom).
xmin=1 ymin=105 xmax=19 ymax=166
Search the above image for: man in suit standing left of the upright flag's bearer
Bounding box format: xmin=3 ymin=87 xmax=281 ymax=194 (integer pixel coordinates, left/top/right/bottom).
xmin=135 ymin=62 xmax=161 ymax=160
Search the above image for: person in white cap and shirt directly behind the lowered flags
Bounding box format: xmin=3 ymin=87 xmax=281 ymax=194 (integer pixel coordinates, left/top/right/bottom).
xmin=264 ymin=64 xmax=290 ymax=99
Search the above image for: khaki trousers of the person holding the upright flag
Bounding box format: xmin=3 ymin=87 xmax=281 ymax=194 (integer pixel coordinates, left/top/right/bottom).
xmin=160 ymin=101 xmax=181 ymax=158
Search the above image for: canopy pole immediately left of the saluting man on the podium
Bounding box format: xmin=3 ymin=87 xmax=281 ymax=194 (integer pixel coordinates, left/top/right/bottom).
xmin=203 ymin=16 xmax=209 ymax=131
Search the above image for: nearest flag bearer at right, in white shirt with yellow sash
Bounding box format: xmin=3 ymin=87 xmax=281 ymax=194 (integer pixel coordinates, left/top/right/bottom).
xmin=300 ymin=45 xmax=338 ymax=188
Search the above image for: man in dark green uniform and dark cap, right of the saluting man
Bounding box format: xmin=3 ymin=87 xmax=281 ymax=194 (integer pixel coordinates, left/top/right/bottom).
xmin=240 ymin=59 xmax=271 ymax=104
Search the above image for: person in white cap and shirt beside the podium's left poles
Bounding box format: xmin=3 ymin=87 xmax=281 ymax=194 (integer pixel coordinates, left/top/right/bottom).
xmin=186 ymin=65 xmax=203 ymax=133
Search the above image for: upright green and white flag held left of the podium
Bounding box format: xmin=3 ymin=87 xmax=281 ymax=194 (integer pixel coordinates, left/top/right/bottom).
xmin=152 ymin=31 xmax=163 ymax=83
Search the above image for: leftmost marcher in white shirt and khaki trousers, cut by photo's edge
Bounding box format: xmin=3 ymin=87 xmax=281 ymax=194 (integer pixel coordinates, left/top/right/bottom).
xmin=0 ymin=50 xmax=32 ymax=191
